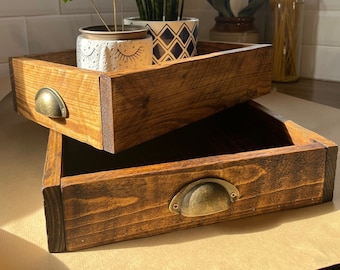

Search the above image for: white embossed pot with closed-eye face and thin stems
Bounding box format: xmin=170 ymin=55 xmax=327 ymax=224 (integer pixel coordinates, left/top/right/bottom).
xmin=63 ymin=0 xmax=152 ymax=72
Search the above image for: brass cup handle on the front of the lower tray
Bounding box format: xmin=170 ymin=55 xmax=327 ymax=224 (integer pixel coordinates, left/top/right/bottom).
xmin=169 ymin=178 xmax=240 ymax=217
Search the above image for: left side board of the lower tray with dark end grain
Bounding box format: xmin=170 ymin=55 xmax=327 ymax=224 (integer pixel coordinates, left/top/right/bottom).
xmin=42 ymin=130 xmax=66 ymax=252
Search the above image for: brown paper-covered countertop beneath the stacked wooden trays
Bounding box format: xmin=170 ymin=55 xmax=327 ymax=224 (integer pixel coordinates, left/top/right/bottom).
xmin=0 ymin=85 xmax=340 ymax=270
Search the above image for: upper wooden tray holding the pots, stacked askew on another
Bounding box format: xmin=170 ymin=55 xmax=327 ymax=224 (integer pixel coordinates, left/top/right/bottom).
xmin=10 ymin=42 xmax=272 ymax=153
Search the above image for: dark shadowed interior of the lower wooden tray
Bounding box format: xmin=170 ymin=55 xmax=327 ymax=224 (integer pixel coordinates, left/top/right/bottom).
xmin=62 ymin=103 xmax=293 ymax=176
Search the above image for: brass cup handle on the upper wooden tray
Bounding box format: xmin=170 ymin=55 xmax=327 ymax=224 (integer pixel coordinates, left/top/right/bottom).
xmin=35 ymin=88 xmax=68 ymax=118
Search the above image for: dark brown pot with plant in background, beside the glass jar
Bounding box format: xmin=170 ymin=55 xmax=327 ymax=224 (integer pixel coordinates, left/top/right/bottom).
xmin=207 ymin=0 xmax=266 ymax=43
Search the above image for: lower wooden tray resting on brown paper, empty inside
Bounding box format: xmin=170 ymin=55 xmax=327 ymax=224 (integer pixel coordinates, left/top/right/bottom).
xmin=43 ymin=101 xmax=337 ymax=252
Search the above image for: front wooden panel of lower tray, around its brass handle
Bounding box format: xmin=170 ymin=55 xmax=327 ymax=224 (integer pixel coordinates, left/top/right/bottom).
xmin=62 ymin=142 xmax=326 ymax=251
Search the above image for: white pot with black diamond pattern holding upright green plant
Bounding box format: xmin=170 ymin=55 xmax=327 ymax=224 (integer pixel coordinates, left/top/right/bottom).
xmin=124 ymin=0 xmax=198 ymax=63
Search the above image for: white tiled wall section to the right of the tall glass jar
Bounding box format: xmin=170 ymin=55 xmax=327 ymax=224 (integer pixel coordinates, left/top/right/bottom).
xmin=301 ymin=0 xmax=340 ymax=81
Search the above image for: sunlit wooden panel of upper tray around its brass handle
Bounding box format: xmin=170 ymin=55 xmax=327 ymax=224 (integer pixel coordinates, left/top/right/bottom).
xmin=10 ymin=57 xmax=103 ymax=149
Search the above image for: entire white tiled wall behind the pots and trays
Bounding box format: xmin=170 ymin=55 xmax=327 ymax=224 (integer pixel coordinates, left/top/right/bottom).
xmin=0 ymin=0 xmax=340 ymax=99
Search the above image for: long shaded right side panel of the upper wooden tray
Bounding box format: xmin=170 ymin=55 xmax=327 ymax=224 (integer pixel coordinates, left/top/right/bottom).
xmin=100 ymin=45 xmax=272 ymax=153
